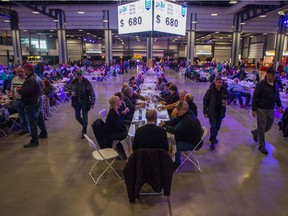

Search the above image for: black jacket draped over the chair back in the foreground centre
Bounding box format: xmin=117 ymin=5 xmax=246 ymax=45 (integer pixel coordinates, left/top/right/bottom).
xmin=123 ymin=149 xmax=173 ymax=202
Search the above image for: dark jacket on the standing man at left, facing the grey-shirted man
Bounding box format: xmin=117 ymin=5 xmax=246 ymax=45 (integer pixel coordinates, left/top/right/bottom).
xmin=19 ymin=73 xmax=43 ymax=105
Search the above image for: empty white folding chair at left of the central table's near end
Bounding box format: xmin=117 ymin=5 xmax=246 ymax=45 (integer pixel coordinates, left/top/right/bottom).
xmin=84 ymin=134 xmax=121 ymax=185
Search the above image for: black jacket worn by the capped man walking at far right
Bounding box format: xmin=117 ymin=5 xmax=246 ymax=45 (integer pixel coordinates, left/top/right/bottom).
xmin=252 ymin=77 xmax=282 ymax=111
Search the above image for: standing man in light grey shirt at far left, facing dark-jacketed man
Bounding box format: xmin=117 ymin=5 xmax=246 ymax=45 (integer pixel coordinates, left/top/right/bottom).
xmin=11 ymin=67 xmax=30 ymax=135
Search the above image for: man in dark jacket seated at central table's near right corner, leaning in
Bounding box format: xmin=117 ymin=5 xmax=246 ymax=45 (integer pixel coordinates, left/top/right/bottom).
xmin=159 ymin=101 xmax=203 ymax=168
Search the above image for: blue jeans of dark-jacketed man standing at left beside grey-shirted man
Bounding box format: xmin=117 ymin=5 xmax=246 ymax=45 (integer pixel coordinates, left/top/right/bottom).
xmin=25 ymin=98 xmax=47 ymax=145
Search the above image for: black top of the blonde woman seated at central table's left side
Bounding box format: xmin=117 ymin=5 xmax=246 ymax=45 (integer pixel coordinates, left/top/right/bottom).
xmin=104 ymin=109 xmax=126 ymax=135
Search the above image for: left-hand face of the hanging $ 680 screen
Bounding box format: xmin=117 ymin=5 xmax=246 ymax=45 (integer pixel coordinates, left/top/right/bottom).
xmin=118 ymin=0 xmax=152 ymax=34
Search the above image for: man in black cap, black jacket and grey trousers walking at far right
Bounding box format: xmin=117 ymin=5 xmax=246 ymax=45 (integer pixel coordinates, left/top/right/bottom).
xmin=251 ymin=67 xmax=283 ymax=154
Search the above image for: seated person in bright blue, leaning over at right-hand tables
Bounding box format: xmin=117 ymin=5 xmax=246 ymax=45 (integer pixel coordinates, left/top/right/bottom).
xmin=228 ymin=78 xmax=251 ymax=108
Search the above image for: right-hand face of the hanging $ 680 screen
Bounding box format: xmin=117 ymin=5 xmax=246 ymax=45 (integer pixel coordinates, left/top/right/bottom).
xmin=154 ymin=0 xmax=187 ymax=35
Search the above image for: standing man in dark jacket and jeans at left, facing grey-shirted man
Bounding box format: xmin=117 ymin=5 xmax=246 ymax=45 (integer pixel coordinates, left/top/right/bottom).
xmin=16 ymin=64 xmax=48 ymax=148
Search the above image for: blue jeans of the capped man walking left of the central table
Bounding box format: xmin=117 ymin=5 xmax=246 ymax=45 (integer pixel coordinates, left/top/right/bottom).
xmin=75 ymin=100 xmax=89 ymax=134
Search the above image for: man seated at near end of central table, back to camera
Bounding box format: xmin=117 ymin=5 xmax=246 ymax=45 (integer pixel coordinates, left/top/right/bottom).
xmin=133 ymin=110 xmax=168 ymax=151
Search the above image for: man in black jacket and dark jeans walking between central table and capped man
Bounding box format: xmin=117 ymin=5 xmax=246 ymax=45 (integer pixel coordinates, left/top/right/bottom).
xmin=203 ymin=77 xmax=229 ymax=150
